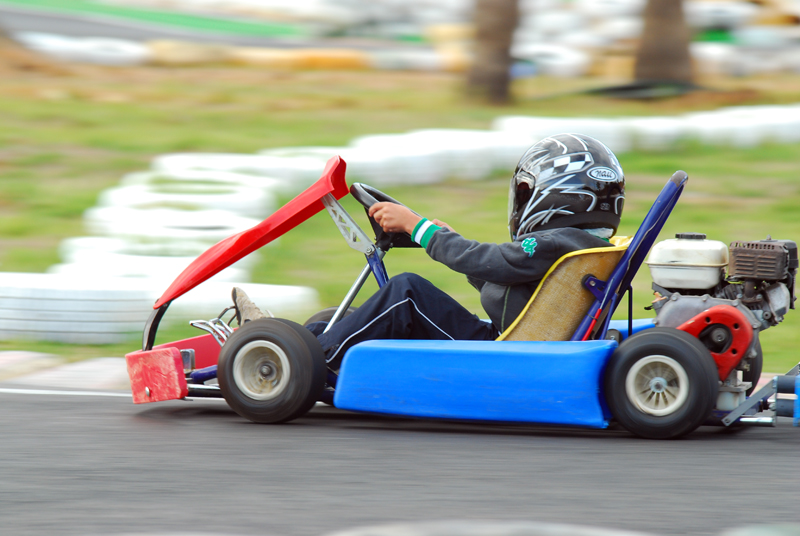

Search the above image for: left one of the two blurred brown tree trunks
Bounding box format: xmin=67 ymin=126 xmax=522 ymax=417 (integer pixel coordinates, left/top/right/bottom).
xmin=467 ymin=0 xmax=519 ymax=104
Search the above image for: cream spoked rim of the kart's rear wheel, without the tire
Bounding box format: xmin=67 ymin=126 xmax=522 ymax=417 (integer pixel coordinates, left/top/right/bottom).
xmin=625 ymin=355 xmax=689 ymax=417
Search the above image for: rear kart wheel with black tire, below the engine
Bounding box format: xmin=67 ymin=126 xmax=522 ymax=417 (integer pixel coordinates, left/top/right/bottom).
xmin=604 ymin=328 xmax=719 ymax=439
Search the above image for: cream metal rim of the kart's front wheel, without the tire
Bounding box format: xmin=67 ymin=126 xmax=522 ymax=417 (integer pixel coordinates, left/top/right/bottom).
xmin=233 ymin=341 xmax=291 ymax=400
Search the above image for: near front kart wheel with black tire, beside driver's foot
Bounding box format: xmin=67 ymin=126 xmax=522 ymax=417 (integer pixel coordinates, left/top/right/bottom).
xmin=217 ymin=318 xmax=326 ymax=424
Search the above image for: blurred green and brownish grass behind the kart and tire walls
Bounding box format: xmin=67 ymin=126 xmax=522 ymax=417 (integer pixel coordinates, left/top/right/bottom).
xmin=0 ymin=68 xmax=800 ymax=371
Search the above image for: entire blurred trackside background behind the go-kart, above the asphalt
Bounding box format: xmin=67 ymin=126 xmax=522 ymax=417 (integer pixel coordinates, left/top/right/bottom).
xmin=0 ymin=0 xmax=800 ymax=372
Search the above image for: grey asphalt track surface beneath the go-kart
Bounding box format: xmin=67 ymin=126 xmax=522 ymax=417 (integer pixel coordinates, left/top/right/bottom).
xmin=0 ymin=384 xmax=800 ymax=535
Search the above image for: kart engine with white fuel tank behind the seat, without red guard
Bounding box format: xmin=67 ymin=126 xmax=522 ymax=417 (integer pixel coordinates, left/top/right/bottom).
xmin=647 ymin=233 xmax=798 ymax=409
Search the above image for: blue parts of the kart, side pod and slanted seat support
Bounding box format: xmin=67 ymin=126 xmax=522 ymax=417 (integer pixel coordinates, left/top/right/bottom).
xmin=331 ymin=171 xmax=688 ymax=428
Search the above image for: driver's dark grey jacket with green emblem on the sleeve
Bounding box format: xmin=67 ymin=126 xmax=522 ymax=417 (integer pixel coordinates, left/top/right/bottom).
xmin=426 ymin=227 xmax=610 ymax=333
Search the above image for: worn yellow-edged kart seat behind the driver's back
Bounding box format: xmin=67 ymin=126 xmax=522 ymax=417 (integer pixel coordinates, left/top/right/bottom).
xmin=497 ymin=241 xmax=630 ymax=341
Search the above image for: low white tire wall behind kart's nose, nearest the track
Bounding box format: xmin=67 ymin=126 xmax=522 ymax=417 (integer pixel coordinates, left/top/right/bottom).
xmin=0 ymin=271 xmax=319 ymax=344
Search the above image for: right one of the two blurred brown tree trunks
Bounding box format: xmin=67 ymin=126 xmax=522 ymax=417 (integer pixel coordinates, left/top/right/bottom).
xmin=635 ymin=0 xmax=692 ymax=84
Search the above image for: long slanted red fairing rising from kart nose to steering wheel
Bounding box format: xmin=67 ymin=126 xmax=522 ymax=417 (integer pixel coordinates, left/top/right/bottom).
xmin=153 ymin=156 xmax=348 ymax=309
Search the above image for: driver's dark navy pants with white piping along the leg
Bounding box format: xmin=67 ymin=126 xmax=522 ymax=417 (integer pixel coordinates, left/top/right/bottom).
xmin=308 ymin=273 xmax=499 ymax=370
